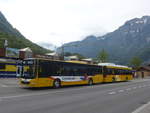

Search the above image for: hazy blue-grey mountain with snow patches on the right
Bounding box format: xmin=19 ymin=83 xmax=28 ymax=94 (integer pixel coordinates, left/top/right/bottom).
xmin=60 ymin=16 xmax=150 ymax=64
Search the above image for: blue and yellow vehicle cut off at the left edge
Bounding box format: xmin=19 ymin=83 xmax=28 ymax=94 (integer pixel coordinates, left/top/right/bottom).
xmin=0 ymin=57 xmax=18 ymax=78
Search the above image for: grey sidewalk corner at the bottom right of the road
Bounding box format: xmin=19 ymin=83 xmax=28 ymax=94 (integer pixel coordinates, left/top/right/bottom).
xmin=132 ymin=102 xmax=150 ymax=113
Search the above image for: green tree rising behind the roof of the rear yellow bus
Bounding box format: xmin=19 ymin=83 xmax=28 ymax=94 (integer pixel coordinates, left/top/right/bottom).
xmin=97 ymin=49 xmax=108 ymax=63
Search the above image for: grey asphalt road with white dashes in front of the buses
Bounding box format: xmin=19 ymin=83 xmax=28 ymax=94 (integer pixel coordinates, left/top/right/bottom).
xmin=0 ymin=79 xmax=150 ymax=113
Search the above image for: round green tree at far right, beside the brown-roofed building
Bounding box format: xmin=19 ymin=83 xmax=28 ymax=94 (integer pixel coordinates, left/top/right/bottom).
xmin=130 ymin=56 xmax=142 ymax=69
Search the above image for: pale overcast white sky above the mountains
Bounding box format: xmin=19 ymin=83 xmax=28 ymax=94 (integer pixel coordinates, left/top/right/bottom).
xmin=0 ymin=0 xmax=150 ymax=45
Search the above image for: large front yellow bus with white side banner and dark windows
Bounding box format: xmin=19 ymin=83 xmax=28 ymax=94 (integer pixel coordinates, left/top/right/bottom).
xmin=17 ymin=58 xmax=103 ymax=88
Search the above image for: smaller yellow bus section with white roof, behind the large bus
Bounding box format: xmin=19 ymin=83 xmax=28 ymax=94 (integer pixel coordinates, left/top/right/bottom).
xmin=99 ymin=64 xmax=133 ymax=82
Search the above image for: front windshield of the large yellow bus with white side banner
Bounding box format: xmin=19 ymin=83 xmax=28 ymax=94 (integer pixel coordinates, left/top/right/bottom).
xmin=21 ymin=60 xmax=35 ymax=79
